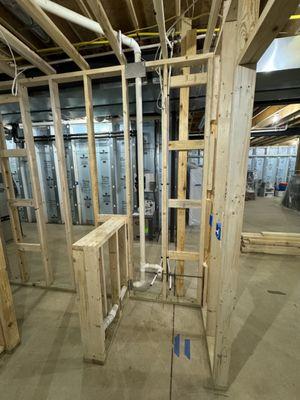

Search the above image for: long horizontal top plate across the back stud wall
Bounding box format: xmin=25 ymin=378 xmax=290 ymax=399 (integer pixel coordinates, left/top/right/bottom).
xmin=0 ymin=53 xmax=213 ymax=90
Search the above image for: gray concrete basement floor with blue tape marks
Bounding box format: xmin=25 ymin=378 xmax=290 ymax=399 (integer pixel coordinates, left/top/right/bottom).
xmin=0 ymin=199 xmax=300 ymax=400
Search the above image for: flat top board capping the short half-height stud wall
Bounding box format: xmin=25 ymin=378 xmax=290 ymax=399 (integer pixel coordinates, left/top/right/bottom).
xmin=73 ymin=218 xmax=124 ymax=250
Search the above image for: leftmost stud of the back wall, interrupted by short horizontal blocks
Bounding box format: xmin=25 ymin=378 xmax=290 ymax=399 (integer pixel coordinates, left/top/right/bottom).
xmin=0 ymin=119 xmax=29 ymax=282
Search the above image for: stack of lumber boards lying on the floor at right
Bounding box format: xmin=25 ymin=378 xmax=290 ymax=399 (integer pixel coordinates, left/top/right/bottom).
xmin=241 ymin=232 xmax=300 ymax=256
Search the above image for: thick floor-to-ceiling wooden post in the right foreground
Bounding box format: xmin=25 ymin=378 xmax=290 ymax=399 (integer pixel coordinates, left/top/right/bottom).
xmin=208 ymin=0 xmax=258 ymax=388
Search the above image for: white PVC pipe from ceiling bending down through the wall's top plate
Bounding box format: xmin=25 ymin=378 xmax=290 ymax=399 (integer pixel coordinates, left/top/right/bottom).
xmin=34 ymin=0 xmax=146 ymax=276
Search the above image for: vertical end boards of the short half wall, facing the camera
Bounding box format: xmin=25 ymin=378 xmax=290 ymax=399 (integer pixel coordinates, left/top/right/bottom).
xmin=73 ymin=248 xmax=106 ymax=364
